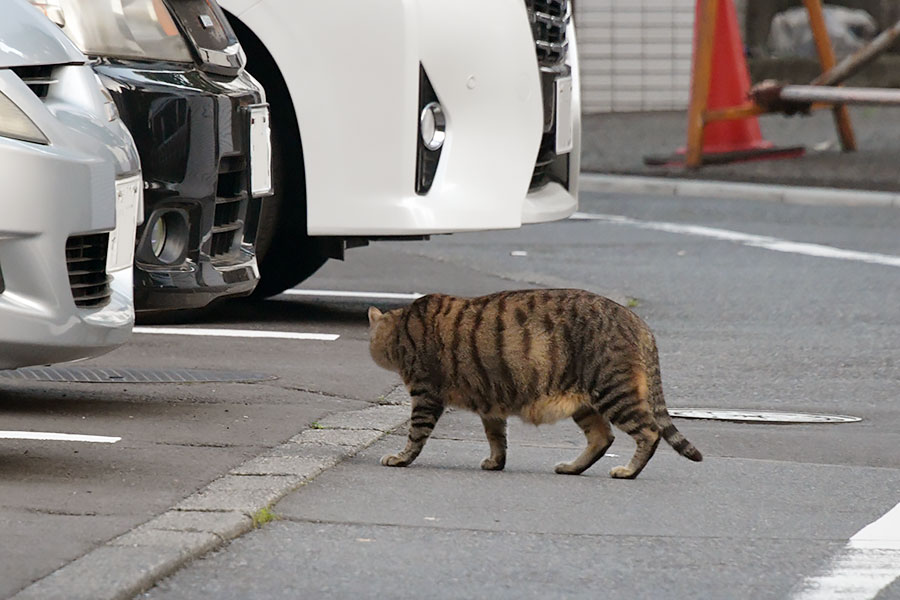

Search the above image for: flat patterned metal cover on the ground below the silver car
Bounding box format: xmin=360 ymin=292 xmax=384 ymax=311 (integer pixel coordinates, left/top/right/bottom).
xmin=0 ymin=367 xmax=277 ymax=383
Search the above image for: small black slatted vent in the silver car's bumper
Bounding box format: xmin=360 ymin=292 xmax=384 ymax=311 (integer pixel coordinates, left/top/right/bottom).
xmin=66 ymin=233 xmax=112 ymax=308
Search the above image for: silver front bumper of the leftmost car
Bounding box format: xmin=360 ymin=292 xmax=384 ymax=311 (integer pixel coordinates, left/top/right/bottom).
xmin=0 ymin=66 xmax=140 ymax=369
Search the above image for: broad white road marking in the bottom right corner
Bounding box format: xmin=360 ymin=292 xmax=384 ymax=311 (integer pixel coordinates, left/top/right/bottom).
xmin=793 ymin=504 xmax=900 ymax=600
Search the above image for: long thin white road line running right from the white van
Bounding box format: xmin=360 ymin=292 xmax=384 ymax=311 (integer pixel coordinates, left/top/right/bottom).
xmin=570 ymin=212 xmax=900 ymax=267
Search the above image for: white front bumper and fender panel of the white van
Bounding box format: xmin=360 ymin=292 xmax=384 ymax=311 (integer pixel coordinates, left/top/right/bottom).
xmin=232 ymin=0 xmax=580 ymax=236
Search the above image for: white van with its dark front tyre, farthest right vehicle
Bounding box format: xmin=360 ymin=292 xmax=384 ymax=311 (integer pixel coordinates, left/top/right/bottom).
xmin=219 ymin=0 xmax=581 ymax=295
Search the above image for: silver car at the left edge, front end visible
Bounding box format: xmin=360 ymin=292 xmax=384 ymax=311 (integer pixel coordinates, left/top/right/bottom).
xmin=0 ymin=0 xmax=143 ymax=369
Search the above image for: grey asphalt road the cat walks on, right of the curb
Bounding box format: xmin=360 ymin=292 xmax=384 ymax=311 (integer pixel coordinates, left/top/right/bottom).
xmin=126 ymin=189 xmax=900 ymax=600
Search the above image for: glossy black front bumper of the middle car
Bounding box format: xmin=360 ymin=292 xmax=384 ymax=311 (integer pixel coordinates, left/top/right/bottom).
xmin=94 ymin=60 xmax=262 ymax=312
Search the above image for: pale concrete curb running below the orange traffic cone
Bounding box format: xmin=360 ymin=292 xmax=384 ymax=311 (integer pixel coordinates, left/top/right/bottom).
xmin=579 ymin=173 xmax=900 ymax=208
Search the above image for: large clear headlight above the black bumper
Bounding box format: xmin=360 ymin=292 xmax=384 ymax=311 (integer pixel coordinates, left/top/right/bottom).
xmin=30 ymin=0 xmax=193 ymax=62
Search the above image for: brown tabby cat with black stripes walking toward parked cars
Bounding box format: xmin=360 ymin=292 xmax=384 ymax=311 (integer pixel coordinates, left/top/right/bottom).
xmin=369 ymin=290 xmax=703 ymax=478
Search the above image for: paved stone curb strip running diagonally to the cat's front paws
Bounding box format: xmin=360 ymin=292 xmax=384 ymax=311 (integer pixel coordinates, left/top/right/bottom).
xmin=12 ymin=386 xmax=409 ymax=600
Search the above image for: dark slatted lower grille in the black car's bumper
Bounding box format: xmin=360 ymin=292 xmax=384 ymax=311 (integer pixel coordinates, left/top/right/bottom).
xmin=209 ymin=156 xmax=248 ymax=263
